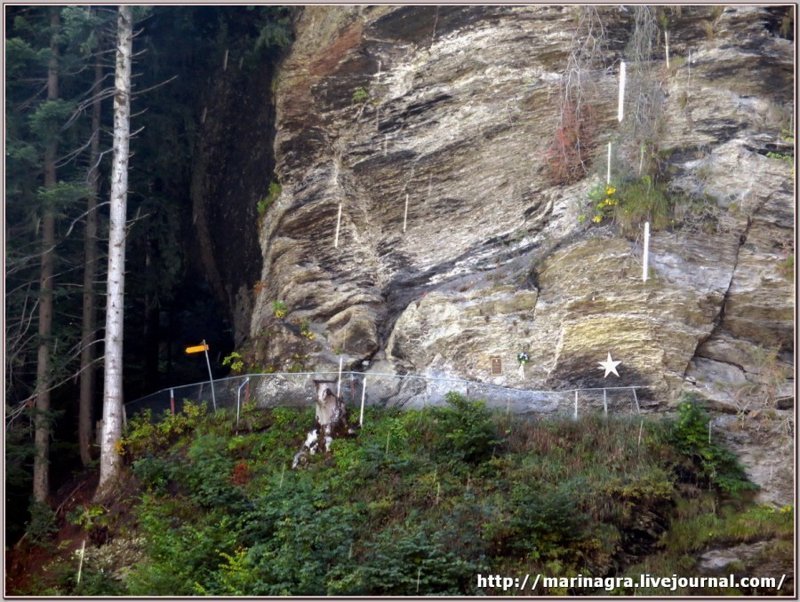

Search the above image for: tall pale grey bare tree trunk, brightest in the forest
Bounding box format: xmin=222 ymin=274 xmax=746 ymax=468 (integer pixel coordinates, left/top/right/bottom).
xmin=95 ymin=6 xmax=133 ymax=499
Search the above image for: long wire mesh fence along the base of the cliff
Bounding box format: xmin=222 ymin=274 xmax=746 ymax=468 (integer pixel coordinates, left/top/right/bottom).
xmin=125 ymin=372 xmax=649 ymax=418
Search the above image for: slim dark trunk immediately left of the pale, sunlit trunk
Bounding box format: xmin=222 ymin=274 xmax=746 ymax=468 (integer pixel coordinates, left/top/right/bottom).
xmin=78 ymin=55 xmax=103 ymax=466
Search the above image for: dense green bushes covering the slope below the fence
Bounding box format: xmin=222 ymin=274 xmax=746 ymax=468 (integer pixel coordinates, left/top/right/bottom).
xmin=26 ymin=394 xmax=791 ymax=596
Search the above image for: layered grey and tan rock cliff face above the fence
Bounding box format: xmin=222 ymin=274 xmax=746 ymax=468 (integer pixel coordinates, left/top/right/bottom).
xmin=234 ymin=6 xmax=794 ymax=496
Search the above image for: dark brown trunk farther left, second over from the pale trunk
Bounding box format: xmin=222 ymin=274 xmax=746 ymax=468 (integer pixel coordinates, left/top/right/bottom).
xmin=33 ymin=7 xmax=61 ymax=502
